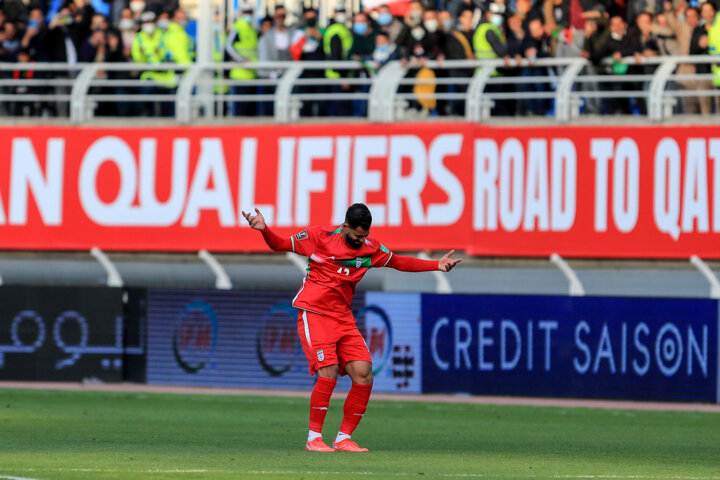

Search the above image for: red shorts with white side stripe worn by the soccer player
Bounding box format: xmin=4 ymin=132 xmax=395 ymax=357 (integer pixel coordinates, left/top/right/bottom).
xmin=298 ymin=310 xmax=372 ymax=375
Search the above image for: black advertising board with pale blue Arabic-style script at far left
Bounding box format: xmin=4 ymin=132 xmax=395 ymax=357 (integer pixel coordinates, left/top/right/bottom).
xmin=0 ymin=287 xmax=136 ymax=382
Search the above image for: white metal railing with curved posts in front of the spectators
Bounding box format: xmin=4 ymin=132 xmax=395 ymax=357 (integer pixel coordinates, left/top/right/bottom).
xmin=0 ymin=56 xmax=720 ymax=124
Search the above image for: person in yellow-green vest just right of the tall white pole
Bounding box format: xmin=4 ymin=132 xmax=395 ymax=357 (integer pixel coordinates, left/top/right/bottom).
xmin=225 ymin=3 xmax=258 ymax=117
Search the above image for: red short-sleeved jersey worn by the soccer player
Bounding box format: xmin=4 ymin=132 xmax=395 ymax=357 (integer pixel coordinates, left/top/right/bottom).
xmin=291 ymin=227 xmax=393 ymax=317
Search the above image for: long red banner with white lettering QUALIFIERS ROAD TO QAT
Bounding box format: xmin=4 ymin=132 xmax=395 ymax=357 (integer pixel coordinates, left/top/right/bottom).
xmin=0 ymin=123 xmax=720 ymax=258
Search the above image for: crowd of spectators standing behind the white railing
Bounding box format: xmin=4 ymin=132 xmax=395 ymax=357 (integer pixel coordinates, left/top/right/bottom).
xmin=0 ymin=0 xmax=720 ymax=116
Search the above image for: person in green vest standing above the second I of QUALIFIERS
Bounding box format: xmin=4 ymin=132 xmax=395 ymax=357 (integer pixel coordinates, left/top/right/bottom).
xmin=323 ymin=3 xmax=353 ymax=117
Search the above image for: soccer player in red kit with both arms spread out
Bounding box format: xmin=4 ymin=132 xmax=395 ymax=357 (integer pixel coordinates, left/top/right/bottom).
xmin=243 ymin=203 xmax=461 ymax=452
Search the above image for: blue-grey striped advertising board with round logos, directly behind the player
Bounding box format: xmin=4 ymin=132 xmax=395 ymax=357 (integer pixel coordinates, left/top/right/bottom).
xmin=147 ymin=289 xmax=364 ymax=389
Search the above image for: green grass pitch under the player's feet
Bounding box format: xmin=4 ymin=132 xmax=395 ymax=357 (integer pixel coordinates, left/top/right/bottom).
xmin=0 ymin=389 xmax=720 ymax=480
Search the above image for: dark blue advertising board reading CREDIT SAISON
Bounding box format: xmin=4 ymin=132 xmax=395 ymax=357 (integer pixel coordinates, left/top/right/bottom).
xmin=422 ymin=295 xmax=718 ymax=403
